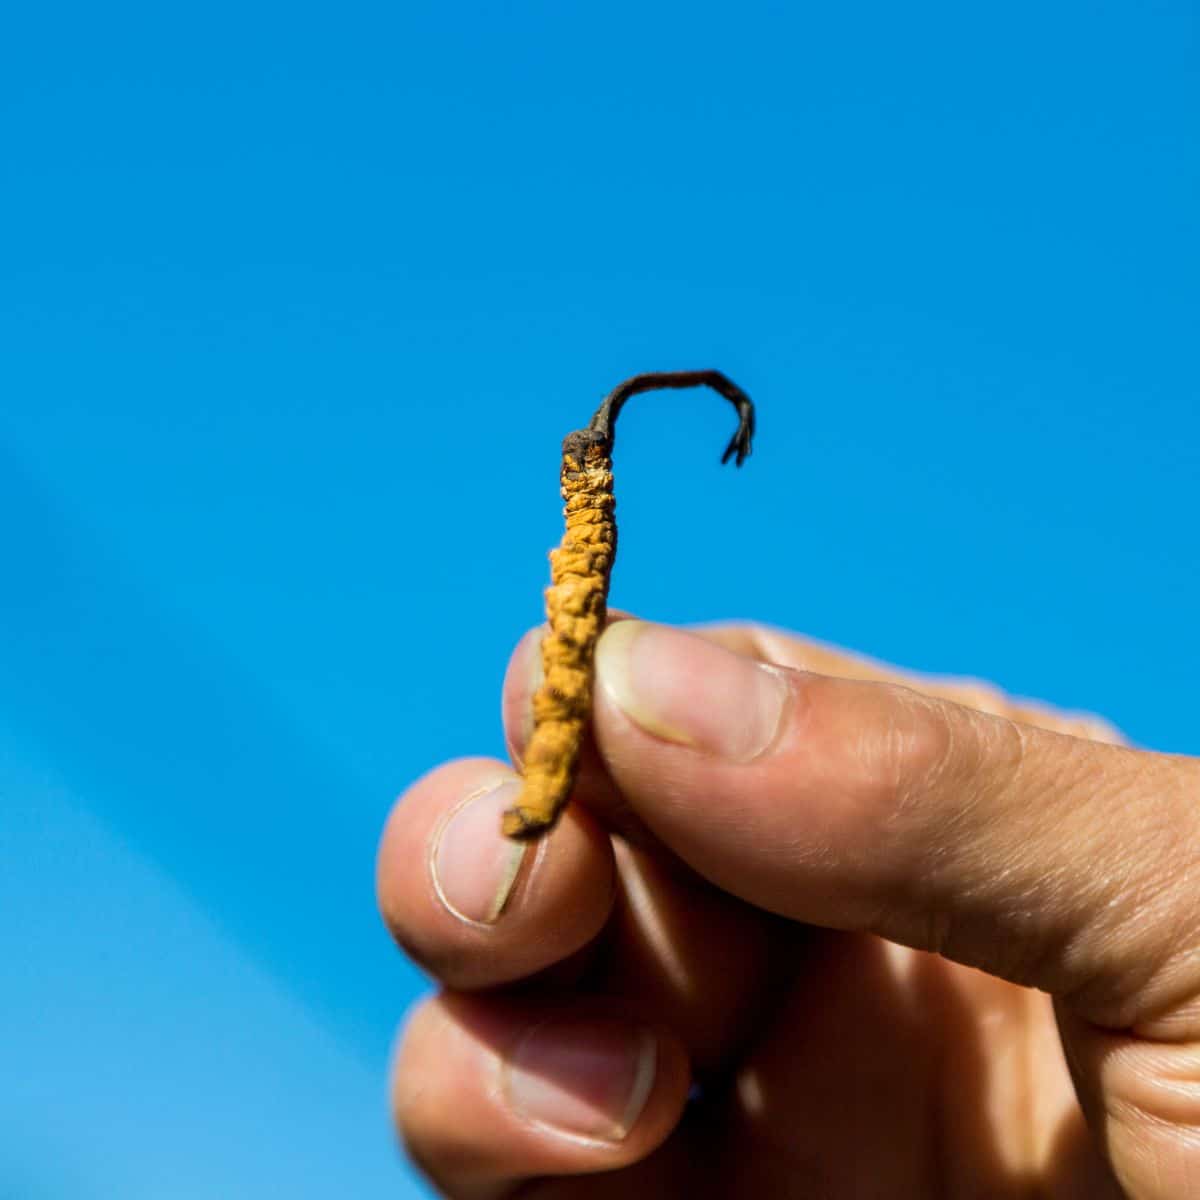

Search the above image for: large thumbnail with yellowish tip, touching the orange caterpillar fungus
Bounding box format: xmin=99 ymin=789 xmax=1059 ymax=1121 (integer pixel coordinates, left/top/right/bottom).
xmin=596 ymin=620 xmax=791 ymax=762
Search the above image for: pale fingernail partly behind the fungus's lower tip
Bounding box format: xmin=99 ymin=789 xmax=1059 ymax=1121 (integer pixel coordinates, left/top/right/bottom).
xmin=430 ymin=779 xmax=532 ymax=925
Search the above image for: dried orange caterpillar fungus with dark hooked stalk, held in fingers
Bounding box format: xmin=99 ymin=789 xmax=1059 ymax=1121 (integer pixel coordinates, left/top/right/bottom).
xmin=500 ymin=371 xmax=755 ymax=841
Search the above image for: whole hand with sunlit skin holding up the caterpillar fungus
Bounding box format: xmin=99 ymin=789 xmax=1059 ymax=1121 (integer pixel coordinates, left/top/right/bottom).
xmin=378 ymin=620 xmax=1200 ymax=1200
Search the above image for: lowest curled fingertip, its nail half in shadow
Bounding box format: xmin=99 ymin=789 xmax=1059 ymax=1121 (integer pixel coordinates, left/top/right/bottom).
xmin=391 ymin=994 xmax=690 ymax=1188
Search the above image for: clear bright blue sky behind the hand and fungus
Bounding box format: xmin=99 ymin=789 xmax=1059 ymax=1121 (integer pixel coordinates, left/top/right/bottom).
xmin=0 ymin=0 xmax=1200 ymax=1200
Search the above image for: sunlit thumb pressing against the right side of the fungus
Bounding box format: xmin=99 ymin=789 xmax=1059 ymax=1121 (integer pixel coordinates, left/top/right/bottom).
xmin=594 ymin=620 xmax=1200 ymax=1039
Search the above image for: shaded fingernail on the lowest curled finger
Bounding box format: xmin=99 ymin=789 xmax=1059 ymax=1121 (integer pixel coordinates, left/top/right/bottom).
xmin=504 ymin=1018 xmax=658 ymax=1142
